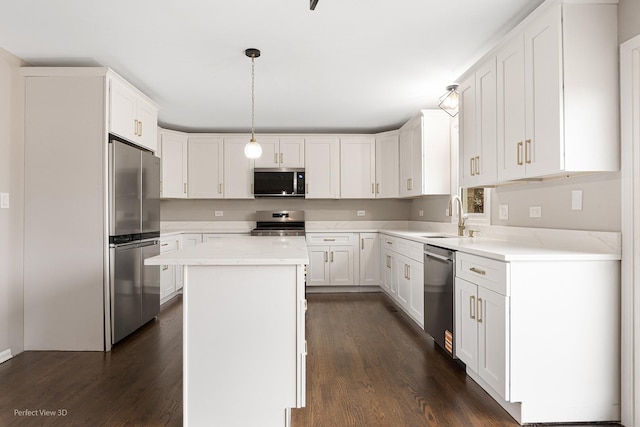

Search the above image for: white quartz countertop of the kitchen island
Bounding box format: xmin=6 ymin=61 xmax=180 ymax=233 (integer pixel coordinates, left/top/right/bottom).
xmin=145 ymin=236 xmax=309 ymax=265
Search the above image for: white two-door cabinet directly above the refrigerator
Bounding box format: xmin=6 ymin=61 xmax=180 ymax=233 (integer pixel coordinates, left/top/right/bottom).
xmin=109 ymin=75 xmax=158 ymax=152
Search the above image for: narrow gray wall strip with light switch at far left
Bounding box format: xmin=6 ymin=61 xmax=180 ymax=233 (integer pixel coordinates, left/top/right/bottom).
xmin=0 ymin=49 xmax=24 ymax=355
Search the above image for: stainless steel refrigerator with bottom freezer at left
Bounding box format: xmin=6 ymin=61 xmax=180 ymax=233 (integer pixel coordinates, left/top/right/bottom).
xmin=109 ymin=138 xmax=160 ymax=344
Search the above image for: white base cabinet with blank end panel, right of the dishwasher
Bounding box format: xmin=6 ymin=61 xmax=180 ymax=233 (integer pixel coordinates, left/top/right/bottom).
xmin=454 ymin=252 xmax=620 ymax=424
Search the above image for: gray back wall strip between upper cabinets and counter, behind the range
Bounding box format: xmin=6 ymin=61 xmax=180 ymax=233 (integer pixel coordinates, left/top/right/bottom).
xmin=160 ymin=199 xmax=411 ymax=221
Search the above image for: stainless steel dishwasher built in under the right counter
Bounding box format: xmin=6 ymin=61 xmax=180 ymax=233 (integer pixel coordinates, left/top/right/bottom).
xmin=424 ymin=245 xmax=456 ymax=357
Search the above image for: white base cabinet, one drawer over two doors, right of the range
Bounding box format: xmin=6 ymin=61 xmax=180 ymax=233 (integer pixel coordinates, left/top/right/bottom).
xmin=307 ymin=233 xmax=359 ymax=286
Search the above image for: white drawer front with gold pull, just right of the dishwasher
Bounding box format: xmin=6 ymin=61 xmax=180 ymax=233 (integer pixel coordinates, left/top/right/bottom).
xmin=456 ymin=252 xmax=509 ymax=296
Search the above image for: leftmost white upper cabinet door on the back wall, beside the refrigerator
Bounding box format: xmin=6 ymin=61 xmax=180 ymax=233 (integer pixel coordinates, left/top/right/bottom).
xmin=160 ymin=133 xmax=187 ymax=199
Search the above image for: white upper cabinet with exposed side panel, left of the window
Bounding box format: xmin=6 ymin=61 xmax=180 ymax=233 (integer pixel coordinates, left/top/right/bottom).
xmin=399 ymin=109 xmax=451 ymax=197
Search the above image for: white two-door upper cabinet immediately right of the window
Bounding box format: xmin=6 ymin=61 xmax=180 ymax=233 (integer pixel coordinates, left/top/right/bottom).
xmin=458 ymin=56 xmax=497 ymax=187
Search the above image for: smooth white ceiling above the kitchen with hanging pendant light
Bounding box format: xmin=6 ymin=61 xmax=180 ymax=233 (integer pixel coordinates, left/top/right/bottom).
xmin=0 ymin=0 xmax=542 ymax=132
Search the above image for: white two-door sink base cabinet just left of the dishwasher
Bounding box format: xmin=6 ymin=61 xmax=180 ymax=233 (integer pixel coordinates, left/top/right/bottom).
xmin=380 ymin=235 xmax=424 ymax=327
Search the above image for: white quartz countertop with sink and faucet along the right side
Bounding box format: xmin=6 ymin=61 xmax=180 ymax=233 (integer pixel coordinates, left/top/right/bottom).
xmin=381 ymin=230 xmax=620 ymax=261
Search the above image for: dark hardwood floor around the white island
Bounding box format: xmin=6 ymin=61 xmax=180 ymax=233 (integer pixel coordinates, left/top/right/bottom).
xmin=0 ymin=293 xmax=620 ymax=427
